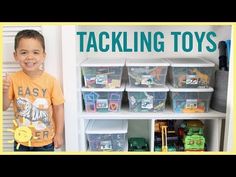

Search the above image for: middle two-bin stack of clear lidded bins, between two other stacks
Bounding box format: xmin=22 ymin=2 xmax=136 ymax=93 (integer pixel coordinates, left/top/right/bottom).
xmin=126 ymin=59 xmax=169 ymax=112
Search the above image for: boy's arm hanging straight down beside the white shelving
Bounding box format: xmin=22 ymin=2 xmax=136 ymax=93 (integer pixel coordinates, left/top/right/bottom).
xmin=53 ymin=104 xmax=64 ymax=148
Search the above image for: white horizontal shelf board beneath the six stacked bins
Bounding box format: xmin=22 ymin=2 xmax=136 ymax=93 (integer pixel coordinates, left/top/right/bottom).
xmin=79 ymin=108 xmax=226 ymax=119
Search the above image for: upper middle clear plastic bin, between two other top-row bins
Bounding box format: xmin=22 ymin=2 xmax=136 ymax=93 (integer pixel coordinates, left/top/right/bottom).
xmin=126 ymin=59 xmax=169 ymax=88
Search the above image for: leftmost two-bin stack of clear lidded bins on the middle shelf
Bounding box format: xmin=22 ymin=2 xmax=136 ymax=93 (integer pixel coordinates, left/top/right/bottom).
xmin=81 ymin=59 xmax=125 ymax=112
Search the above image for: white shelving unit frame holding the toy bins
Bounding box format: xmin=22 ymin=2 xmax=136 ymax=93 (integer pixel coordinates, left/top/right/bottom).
xmin=62 ymin=26 xmax=232 ymax=152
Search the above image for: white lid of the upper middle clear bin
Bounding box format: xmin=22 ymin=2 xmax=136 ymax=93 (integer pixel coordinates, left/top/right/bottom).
xmin=126 ymin=58 xmax=170 ymax=66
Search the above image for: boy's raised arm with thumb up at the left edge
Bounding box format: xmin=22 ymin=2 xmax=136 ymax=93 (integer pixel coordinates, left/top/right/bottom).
xmin=3 ymin=74 xmax=11 ymax=111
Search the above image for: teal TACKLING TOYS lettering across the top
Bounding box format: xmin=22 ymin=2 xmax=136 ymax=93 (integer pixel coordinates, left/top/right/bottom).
xmin=77 ymin=31 xmax=217 ymax=52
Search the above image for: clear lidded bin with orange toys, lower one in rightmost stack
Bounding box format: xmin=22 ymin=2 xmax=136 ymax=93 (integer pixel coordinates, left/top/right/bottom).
xmin=169 ymin=86 xmax=213 ymax=113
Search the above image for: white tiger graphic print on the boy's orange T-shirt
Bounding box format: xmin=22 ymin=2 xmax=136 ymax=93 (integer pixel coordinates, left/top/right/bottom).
xmin=16 ymin=97 xmax=50 ymax=130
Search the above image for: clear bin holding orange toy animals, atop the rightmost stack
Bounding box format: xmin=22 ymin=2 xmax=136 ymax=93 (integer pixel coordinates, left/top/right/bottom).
xmin=168 ymin=58 xmax=215 ymax=88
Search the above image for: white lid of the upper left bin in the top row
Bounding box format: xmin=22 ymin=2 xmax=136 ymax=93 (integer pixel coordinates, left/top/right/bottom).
xmin=80 ymin=58 xmax=125 ymax=67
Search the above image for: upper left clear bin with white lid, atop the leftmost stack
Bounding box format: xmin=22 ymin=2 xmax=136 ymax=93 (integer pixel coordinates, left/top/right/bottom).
xmin=80 ymin=59 xmax=125 ymax=88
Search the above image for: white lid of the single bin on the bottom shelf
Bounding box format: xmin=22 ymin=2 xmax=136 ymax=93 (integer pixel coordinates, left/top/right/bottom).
xmin=85 ymin=120 xmax=128 ymax=134
